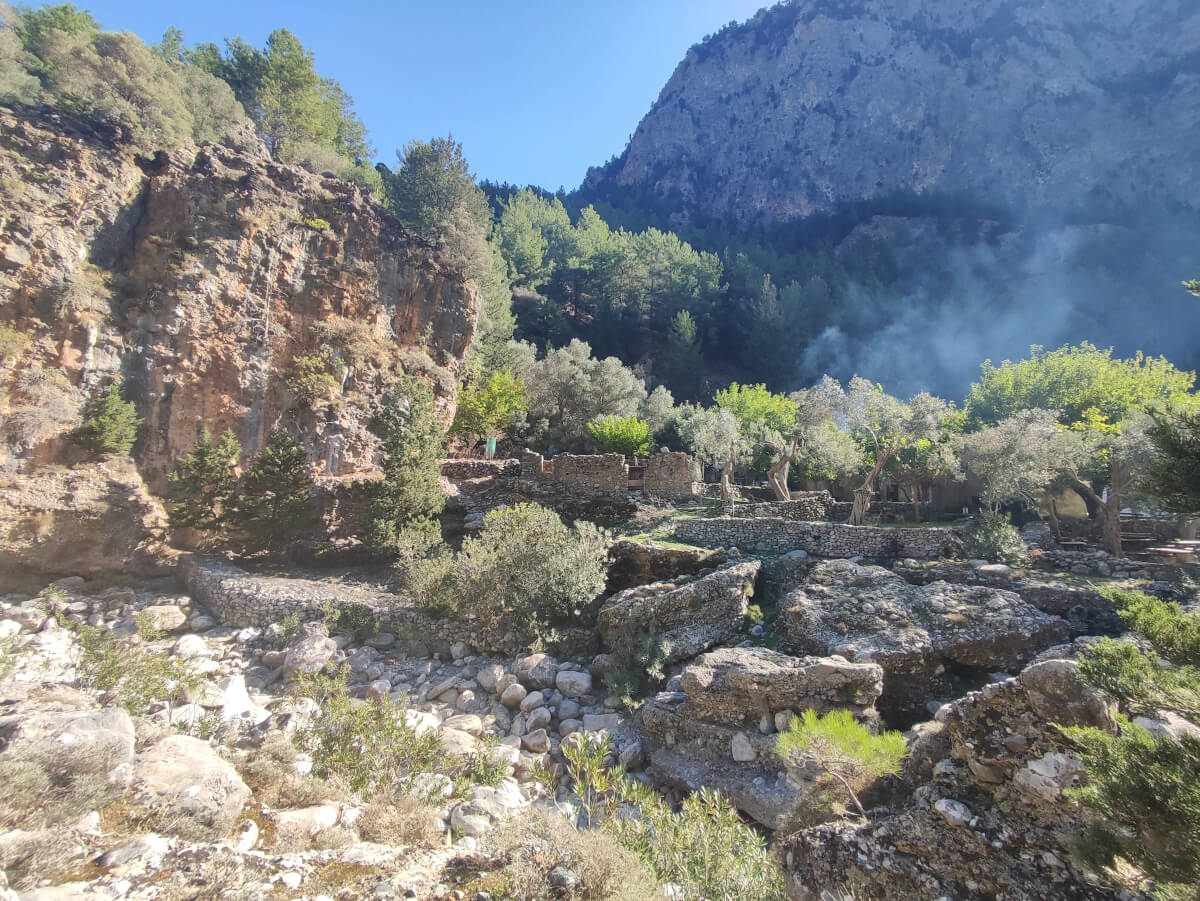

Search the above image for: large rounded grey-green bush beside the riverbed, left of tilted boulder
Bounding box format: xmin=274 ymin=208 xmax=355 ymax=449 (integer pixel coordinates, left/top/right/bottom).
xmin=409 ymin=504 xmax=608 ymax=632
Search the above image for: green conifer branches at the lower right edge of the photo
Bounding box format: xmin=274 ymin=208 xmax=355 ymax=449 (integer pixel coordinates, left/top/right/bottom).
xmin=1063 ymin=590 xmax=1200 ymax=899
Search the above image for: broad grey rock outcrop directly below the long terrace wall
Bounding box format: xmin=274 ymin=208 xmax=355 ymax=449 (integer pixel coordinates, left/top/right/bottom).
xmin=779 ymin=560 xmax=1069 ymax=721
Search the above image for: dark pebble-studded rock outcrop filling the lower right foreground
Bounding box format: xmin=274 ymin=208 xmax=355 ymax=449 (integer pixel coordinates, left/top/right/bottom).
xmin=784 ymin=660 xmax=1118 ymax=901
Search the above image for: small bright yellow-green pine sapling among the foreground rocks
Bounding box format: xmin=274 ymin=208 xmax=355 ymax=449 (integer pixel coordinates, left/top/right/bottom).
xmin=776 ymin=710 xmax=908 ymax=819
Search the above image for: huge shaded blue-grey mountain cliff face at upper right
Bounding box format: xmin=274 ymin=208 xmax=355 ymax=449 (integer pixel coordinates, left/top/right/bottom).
xmin=586 ymin=0 xmax=1200 ymax=226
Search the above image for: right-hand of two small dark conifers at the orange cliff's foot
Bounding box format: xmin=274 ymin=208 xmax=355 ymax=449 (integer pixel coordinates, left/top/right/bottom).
xmin=230 ymin=428 xmax=313 ymax=548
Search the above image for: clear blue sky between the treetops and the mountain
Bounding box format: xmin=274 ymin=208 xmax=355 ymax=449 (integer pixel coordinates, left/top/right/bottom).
xmin=56 ymin=0 xmax=763 ymax=190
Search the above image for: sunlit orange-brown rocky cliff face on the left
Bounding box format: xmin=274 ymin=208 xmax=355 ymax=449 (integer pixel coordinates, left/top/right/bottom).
xmin=0 ymin=110 xmax=479 ymax=491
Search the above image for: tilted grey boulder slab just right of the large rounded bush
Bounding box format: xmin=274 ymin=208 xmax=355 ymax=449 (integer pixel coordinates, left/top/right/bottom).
xmin=596 ymin=560 xmax=762 ymax=663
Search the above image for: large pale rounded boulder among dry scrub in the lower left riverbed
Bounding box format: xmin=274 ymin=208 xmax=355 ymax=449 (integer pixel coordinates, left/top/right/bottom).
xmin=130 ymin=735 xmax=250 ymax=840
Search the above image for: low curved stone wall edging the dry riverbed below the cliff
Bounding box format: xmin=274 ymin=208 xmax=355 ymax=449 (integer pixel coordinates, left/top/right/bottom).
xmin=179 ymin=554 xmax=596 ymax=656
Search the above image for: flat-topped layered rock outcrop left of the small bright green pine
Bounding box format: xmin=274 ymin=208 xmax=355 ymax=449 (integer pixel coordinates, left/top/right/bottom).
xmin=642 ymin=648 xmax=882 ymax=829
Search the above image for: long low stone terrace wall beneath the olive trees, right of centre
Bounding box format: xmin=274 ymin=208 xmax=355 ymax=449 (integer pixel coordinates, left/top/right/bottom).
xmin=674 ymin=518 xmax=962 ymax=559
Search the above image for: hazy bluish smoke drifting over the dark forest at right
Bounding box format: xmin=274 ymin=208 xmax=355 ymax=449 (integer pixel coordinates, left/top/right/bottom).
xmin=799 ymin=216 xmax=1200 ymax=400
